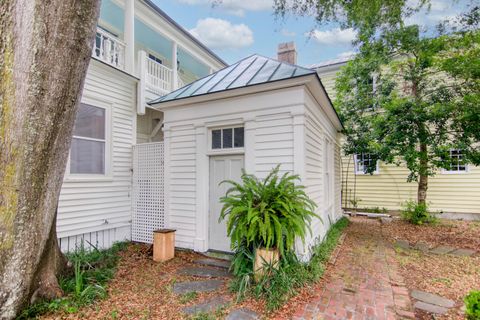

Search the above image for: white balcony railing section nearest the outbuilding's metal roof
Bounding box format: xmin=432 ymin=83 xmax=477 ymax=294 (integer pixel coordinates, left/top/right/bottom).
xmin=145 ymin=58 xmax=173 ymax=96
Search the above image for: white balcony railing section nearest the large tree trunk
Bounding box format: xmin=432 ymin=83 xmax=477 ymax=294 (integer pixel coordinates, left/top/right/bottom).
xmin=92 ymin=28 xmax=125 ymax=70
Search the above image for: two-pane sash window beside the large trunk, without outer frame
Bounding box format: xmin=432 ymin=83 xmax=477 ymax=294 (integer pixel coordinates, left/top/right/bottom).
xmin=70 ymin=103 xmax=107 ymax=175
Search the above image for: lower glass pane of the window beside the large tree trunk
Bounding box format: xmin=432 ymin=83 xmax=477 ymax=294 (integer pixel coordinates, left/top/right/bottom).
xmin=70 ymin=138 xmax=105 ymax=174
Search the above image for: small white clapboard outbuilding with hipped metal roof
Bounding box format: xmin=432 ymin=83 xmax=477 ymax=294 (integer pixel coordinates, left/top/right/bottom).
xmin=150 ymin=55 xmax=342 ymax=259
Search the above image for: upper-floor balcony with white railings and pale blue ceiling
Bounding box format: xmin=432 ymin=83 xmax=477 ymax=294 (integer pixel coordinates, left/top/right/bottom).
xmin=92 ymin=0 xmax=225 ymax=114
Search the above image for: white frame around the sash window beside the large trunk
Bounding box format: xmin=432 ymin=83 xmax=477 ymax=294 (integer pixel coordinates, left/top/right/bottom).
xmin=65 ymin=97 xmax=114 ymax=181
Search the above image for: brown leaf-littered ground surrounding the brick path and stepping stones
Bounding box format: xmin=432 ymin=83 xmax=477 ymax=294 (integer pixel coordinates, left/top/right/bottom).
xmin=42 ymin=218 xmax=480 ymax=319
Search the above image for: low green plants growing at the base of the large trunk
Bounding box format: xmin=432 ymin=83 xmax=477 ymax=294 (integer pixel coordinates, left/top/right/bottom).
xmin=18 ymin=242 xmax=127 ymax=319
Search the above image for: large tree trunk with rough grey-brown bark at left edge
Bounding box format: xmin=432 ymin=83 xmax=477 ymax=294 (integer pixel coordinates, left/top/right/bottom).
xmin=0 ymin=0 xmax=99 ymax=319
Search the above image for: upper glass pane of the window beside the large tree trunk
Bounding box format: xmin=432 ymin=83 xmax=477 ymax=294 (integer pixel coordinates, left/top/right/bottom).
xmin=73 ymin=103 xmax=105 ymax=140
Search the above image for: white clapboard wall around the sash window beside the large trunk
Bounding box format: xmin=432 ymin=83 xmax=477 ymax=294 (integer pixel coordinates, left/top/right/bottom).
xmin=57 ymin=60 xmax=135 ymax=251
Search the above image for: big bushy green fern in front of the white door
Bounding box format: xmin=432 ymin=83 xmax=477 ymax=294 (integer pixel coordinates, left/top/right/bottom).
xmin=220 ymin=166 xmax=318 ymax=258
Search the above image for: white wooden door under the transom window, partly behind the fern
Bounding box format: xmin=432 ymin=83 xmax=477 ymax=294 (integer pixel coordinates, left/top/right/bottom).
xmin=208 ymin=155 xmax=244 ymax=252
